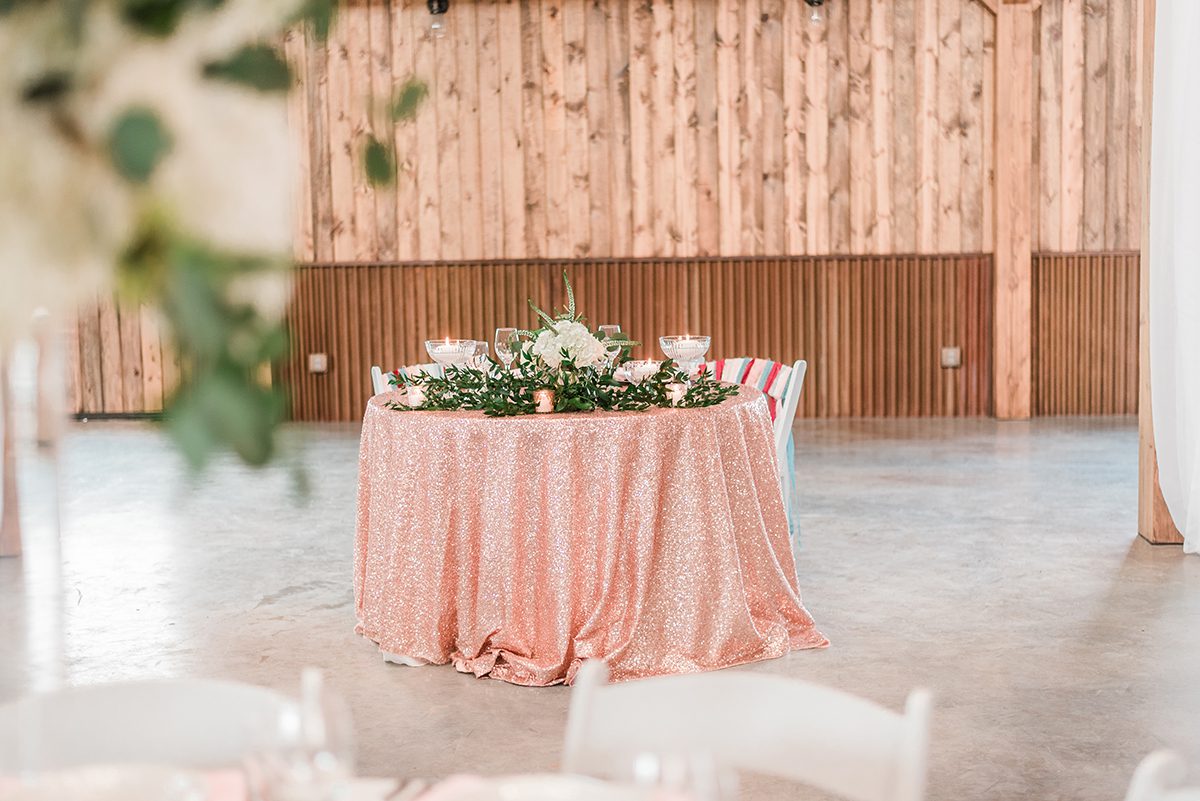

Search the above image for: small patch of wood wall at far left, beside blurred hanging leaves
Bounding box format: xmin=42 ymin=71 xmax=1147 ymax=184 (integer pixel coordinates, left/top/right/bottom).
xmin=64 ymin=297 xmax=180 ymax=415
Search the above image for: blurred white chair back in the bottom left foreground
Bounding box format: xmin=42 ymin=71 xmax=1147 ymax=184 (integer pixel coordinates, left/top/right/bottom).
xmin=0 ymin=680 xmax=288 ymax=775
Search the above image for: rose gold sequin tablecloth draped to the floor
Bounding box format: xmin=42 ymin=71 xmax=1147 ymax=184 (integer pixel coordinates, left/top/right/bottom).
xmin=354 ymin=387 xmax=828 ymax=686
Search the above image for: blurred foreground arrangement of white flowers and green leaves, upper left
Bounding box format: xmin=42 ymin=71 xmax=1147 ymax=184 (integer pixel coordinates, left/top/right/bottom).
xmin=0 ymin=0 xmax=425 ymax=466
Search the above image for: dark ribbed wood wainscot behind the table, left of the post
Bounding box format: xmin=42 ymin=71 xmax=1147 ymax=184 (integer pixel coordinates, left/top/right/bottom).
xmin=282 ymin=257 xmax=991 ymax=421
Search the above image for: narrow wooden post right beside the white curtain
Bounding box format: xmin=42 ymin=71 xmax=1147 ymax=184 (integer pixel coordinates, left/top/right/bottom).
xmin=1135 ymin=0 xmax=1183 ymax=544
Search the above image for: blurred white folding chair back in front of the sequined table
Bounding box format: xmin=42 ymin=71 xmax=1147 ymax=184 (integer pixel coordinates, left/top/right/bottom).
xmin=563 ymin=661 xmax=930 ymax=801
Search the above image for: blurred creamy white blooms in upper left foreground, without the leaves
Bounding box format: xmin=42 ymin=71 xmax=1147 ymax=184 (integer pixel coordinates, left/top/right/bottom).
xmin=0 ymin=0 xmax=296 ymax=343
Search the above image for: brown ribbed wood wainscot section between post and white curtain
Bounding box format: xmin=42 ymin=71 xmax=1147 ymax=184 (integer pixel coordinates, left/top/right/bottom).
xmin=1033 ymin=252 xmax=1139 ymax=415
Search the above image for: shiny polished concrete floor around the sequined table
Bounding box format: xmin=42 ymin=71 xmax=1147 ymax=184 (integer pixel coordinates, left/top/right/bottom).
xmin=0 ymin=420 xmax=1200 ymax=801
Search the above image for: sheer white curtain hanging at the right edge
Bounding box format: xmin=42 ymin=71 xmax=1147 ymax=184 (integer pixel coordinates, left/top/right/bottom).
xmin=1150 ymin=0 xmax=1200 ymax=553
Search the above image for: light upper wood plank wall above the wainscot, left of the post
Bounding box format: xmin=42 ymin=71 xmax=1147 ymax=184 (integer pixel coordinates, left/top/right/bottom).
xmin=287 ymin=0 xmax=1003 ymax=257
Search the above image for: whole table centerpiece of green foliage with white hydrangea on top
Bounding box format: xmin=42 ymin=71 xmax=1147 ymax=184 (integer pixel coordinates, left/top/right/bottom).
xmin=386 ymin=272 xmax=738 ymax=417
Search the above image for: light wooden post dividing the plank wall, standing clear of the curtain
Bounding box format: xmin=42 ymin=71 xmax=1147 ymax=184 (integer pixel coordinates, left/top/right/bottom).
xmin=985 ymin=0 xmax=1042 ymax=420
